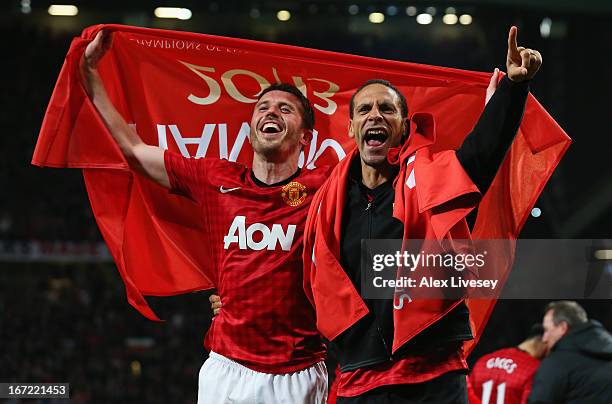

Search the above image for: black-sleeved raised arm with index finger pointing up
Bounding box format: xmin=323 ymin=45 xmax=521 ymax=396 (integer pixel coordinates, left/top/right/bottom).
xmin=457 ymin=27 xmax=542 ymax=194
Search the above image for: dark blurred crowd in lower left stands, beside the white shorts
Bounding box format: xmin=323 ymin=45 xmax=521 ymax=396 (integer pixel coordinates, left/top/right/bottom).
xmin=0 ymin=264 xmax=211 ymax=404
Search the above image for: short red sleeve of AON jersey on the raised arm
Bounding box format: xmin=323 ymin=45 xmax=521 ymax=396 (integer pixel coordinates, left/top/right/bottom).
xmin=164 ymin=150 xmax=222 ymax=202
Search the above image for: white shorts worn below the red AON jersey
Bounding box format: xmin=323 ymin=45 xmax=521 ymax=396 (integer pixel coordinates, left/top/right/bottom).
xmin=198 ymin=352 xmax=327 ymax=404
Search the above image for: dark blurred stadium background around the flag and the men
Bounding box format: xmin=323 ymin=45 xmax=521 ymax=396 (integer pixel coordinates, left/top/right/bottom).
xmin=0 ymin=0 xmax=612 ymax=403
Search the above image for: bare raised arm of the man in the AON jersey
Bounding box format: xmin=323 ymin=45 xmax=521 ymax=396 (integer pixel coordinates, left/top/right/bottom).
xmin=80 ymin=30 xmax=170 ymax=188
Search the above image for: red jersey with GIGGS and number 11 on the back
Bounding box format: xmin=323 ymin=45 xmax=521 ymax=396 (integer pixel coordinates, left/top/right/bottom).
xmin=470 ymin=348 xmax=540 ymax=404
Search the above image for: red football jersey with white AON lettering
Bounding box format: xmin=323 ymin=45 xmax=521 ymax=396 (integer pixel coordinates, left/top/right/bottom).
xmin=165 ymin=151 xmax=329 ymax=373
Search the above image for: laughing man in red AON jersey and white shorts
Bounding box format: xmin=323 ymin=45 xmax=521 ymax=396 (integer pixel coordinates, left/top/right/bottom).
xmin=81 ymin=32 xmax=329 ymax=404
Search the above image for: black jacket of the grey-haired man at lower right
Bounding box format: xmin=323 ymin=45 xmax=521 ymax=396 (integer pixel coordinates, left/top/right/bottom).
xmin=528 ymin=320 xmax=612 ymax=404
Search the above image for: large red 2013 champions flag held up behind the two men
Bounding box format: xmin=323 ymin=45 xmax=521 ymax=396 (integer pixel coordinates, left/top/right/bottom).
xmin=32 ymin=25 xmax=570 ymax=334
